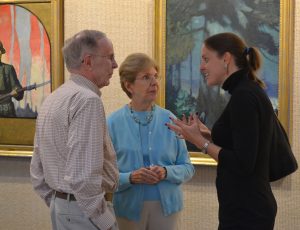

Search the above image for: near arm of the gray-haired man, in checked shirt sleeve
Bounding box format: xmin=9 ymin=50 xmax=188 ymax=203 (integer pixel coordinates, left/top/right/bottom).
xmin=64 ymin=97 xmax=116 ymax=229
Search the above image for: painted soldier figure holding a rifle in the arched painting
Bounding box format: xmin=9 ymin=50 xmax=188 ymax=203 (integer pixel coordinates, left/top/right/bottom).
xmin=0 ymin=41 xmax=24 ymax=117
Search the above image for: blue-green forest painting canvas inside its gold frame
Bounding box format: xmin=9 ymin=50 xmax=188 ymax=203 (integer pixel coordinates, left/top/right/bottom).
xmin=166 ymin=0 xmax=280 ymax=131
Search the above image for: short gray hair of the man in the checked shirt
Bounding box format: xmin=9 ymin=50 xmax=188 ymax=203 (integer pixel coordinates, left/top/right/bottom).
xmin=62 ymin=30 xmax=106 ymax=71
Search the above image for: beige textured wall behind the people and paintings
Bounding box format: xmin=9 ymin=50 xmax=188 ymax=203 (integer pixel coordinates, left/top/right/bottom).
xmin=0 ymin=0 xmax=300 ymax=230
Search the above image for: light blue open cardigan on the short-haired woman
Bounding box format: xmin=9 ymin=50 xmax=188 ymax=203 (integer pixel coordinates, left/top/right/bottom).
xmin=108 ymin=105 xmax=195 ymax=221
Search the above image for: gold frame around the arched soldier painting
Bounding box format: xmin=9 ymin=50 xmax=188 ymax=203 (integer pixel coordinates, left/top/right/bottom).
xmin=0 ymin=0 xmax=64 ymax=157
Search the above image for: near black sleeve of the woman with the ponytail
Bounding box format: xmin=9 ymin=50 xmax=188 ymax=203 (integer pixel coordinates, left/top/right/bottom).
xmin=219 ymin=91 xmax=260 ymax=175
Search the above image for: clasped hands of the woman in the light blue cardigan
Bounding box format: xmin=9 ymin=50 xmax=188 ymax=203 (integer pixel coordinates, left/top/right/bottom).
xmin=130 ymin=166 xmax=161 ymax=184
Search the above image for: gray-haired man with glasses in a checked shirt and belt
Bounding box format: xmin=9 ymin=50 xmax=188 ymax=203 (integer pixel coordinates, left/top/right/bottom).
xmin=30 ymin=30 xmax=118 ymax=230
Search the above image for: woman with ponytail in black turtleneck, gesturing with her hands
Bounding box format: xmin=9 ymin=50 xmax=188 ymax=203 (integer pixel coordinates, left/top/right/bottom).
xmin=168 ymin=33 xmax=277 ymax=230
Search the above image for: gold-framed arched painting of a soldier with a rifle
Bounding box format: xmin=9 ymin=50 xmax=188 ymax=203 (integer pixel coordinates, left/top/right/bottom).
xmin=0 ymin=0 xmax=64 ymax=156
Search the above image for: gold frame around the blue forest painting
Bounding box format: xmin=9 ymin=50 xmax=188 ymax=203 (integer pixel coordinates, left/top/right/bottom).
xmin=154 ymin=0 xmax=295 ymax=165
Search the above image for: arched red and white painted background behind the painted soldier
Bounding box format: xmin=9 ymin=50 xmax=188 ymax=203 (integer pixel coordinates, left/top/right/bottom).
xmin=0 ymin=4 xmax=51 ymax=118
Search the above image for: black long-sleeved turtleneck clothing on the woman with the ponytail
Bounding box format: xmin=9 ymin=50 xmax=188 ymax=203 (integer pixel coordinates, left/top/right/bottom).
xmin=212 ymin=70 xmax=277 ymax=230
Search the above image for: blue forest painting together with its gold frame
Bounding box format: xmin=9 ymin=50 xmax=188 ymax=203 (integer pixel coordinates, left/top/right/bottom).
xmin=154 ymin=0 xmax=294 ymax=165
